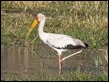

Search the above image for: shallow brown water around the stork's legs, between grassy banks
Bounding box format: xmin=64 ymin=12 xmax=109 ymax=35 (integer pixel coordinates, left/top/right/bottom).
xmin=1 ymin=44 xmax=107 ymax=80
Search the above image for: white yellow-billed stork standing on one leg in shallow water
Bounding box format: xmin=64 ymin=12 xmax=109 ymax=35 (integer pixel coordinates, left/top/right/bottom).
xmin=26 ymin=13 xmax=88 ymax=74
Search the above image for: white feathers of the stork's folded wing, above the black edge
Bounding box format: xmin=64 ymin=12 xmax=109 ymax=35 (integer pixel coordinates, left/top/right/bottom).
xmin=47 ymin=33 xmax=85 ymax=48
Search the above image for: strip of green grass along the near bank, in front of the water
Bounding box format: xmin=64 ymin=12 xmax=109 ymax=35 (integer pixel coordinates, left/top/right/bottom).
xmin=2 ymin=68 xmax=108 ymax=81
